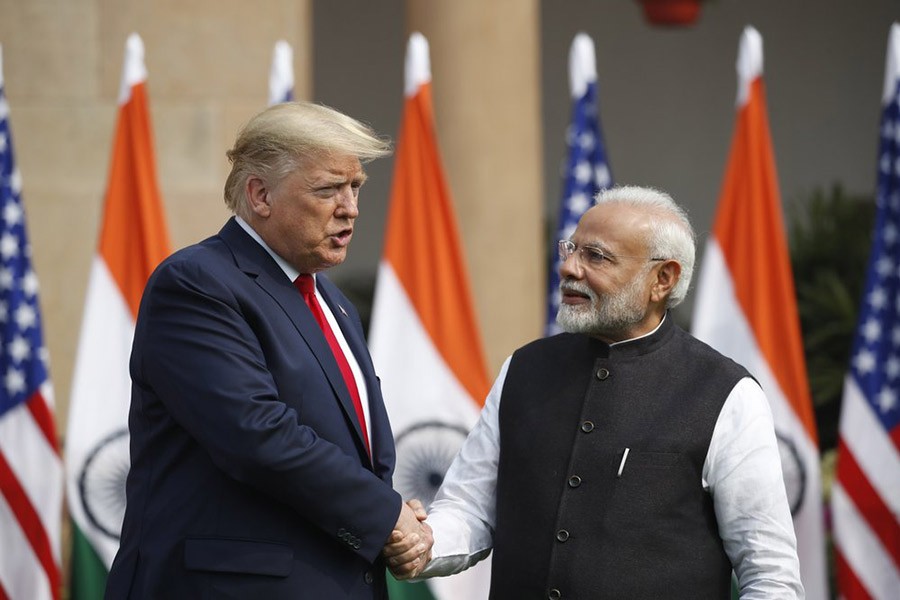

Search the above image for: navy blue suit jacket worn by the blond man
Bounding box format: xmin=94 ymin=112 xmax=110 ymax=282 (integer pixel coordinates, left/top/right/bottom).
xmin=106 ymin=219 xmax=401 ymax=600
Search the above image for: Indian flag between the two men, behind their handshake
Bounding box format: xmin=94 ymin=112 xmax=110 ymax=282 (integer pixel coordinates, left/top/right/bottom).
xmin=369 ymin=33 xmax=490 ymax=600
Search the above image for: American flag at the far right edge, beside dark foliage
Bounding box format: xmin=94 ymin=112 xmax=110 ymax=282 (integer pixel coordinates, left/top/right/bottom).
xmin=832 ymin=24 xmax=900 ymax=600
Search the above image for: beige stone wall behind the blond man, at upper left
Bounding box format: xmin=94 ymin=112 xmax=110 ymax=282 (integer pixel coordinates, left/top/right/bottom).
xmin=0 ymin=0 xmax=312 ymax=437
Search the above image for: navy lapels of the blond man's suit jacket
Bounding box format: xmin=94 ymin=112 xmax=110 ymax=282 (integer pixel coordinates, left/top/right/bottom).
xmin=219 ymin=218 xmax=372 ymax=455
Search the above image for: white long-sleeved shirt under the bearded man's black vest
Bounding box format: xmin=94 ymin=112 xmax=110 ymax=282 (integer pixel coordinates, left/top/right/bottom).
xmin=421 ymin=324 xmax=805 ymax=599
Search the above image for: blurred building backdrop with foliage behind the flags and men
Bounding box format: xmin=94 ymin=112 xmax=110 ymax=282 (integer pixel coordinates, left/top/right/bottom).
xmin=0 ymin=0 xmax=900 ymax=596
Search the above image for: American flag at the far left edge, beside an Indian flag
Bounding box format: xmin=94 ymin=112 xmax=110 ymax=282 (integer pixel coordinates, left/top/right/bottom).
xmin=0 ymin=47 xmax=63 ymax=600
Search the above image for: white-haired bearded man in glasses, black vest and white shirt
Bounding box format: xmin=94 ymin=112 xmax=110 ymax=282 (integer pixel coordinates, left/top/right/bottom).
xmin=388 ymin=187 xmax=804 ymax=600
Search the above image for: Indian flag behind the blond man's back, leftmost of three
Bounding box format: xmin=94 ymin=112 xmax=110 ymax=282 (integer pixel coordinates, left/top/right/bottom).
xmin=66 ymin=34 xmax=171 ymax=600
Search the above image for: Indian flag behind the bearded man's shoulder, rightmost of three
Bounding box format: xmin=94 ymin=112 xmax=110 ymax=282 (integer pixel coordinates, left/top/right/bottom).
xmin=693 ymin=27 xmax=828 ymax=600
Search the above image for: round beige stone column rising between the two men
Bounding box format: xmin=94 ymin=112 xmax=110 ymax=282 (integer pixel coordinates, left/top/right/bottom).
xmin=406 ymin=0 xmax=546 ymax=379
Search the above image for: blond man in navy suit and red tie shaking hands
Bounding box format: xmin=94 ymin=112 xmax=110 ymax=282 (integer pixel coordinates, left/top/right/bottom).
xmin=106 ymin=103 xmax=432 ymax=600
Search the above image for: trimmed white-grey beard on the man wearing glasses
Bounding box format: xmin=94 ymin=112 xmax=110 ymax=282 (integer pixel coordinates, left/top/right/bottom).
xmin=556 ymin=277 xmax=647 ymax=337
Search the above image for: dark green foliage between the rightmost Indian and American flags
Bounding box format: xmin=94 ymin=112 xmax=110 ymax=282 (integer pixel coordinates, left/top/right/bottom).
xmin=789 ymin=184 xmax=875 ymax=450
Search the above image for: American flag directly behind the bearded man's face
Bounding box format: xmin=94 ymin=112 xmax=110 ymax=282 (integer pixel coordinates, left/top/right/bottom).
xmin=545 ymin=33 xmax=612 ymax=335
